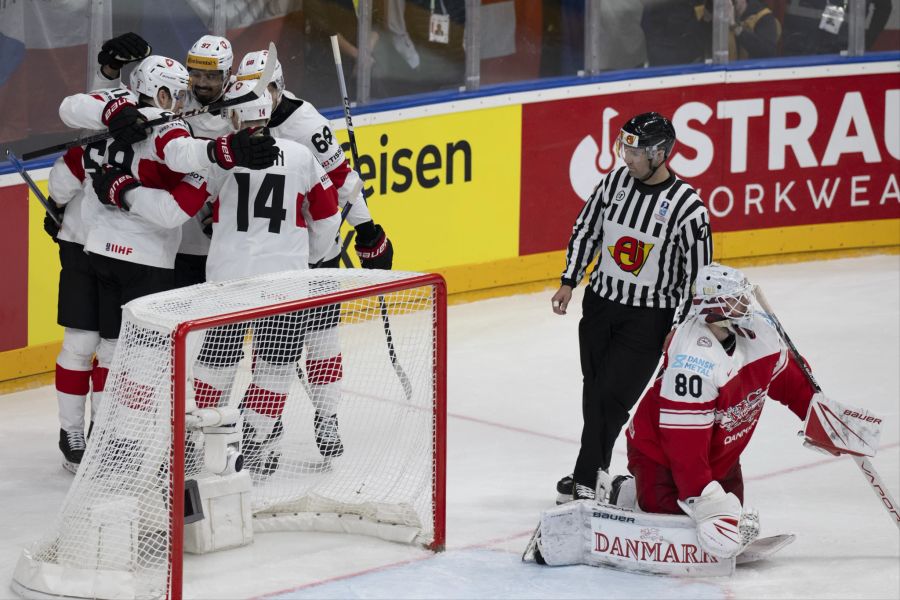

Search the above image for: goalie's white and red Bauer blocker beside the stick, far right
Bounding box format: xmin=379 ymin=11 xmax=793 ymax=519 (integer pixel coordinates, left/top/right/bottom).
xmin=801 ymin=392 xmax=881 ymax=456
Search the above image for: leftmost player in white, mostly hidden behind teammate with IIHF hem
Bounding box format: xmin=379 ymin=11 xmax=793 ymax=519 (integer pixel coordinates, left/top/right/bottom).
xmin=44 ymin=146 xmax=106 ymax=473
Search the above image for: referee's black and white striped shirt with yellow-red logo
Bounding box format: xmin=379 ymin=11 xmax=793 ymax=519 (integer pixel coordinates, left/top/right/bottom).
xmin=562 ymin=167 xmax=712 ymax=308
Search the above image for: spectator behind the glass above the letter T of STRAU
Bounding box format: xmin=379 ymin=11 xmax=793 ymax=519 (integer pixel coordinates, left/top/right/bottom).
xmin=703 ymin=0 xmax=781 ymax=60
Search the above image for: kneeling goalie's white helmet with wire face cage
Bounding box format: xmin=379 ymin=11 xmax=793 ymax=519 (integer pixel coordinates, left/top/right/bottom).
xmin=689 ymin=262 xmax=753 ymax=328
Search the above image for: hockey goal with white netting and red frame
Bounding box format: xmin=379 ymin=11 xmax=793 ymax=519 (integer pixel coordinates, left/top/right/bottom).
xmin=13 ymin=269 xmax=446 ymax=598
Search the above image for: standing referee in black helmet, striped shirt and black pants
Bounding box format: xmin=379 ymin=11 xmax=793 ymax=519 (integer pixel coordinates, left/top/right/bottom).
xmin=552 ymin=112 xmax=712 ymax=502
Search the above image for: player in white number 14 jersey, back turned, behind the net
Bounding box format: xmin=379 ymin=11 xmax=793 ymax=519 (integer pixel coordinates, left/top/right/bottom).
xmin=188 ymin=81 xmax=343 ymax=475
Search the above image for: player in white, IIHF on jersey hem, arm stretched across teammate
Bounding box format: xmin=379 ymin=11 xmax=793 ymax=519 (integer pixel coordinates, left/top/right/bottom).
xmin=60 ymin=56 xmax=276 ymax=418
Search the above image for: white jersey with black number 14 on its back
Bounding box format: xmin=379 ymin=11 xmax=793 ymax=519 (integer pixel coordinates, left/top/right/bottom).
xmin=206 ymin=138 xmax=341 ymax=281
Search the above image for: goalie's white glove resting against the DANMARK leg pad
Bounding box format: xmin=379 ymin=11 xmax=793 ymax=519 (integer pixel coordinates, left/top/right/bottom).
xmin=678 ymin=481 xmax=759 ymax=558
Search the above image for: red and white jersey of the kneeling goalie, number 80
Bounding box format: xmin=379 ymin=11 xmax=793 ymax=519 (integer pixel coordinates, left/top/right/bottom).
xmin=627 ymin=314 xmax=813 ymax=500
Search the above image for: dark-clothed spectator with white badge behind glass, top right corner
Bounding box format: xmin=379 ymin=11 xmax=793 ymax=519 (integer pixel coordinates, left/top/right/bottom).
xmin=782 ymin=0 xmax=891 ymax=56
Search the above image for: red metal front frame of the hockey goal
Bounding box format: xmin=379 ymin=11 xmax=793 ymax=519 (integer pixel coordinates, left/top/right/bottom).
xmin=167 ymin=274 xmax=447 ymax=600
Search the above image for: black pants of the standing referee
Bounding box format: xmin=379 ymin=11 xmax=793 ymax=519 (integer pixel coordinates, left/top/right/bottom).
xmin=574 ymin=288 xmax=675 ymax=487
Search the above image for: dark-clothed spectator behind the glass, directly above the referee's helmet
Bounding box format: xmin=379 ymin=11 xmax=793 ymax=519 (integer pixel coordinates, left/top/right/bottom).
xmin=641 ymin=0 xmax=707 ymax=67
